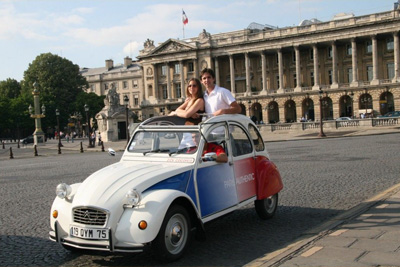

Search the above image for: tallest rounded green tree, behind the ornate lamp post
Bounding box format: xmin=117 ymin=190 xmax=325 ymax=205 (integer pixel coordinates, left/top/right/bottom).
xmin=22 ymin=53 xmax=88 ymax=134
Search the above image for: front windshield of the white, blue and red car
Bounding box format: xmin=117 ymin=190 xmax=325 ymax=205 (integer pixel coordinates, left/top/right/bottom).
xmin=128 ymin=130 xmax=200 ymax=156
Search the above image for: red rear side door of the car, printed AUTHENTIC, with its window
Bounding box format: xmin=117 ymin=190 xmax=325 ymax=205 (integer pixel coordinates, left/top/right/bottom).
xmin=229 ymin=124 xmax=256 ymax=203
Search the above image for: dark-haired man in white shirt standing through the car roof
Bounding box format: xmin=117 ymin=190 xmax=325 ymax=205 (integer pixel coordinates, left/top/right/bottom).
xmin=200 ymin=68 xmax=242 ymax=116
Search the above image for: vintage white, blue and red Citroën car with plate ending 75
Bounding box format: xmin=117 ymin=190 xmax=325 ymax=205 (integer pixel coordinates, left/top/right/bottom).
xmin=49 ymin=115 xmax=283 ymax=261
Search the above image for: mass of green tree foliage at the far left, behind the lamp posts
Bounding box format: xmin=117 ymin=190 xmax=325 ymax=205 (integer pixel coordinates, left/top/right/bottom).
xmin=0 ymin=53 xmax=104 ymax=138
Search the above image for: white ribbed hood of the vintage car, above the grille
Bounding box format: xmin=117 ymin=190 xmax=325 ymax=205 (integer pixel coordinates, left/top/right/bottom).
xmin=73 ymin=161 xmax=193 ymax=209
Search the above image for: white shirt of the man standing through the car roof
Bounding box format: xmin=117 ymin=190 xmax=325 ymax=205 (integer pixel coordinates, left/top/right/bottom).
xmin=204 ymin=85 xmax=236 ymax=113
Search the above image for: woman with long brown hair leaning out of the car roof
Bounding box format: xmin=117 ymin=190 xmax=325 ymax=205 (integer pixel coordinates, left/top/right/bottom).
xmin=169 ymin=78 xmax=204 ymax=125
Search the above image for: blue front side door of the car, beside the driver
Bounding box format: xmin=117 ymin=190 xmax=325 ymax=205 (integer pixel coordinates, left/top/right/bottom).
xmin=196 ymin=123 xmax=237 ymax=221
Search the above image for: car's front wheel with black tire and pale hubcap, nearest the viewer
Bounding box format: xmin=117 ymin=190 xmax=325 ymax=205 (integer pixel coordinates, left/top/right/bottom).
xmin=152 ymin=205 xmax=191 ymax=262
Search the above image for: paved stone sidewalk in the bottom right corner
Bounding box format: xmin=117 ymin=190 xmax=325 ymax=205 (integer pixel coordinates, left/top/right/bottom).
xmin=250 ymin=184 xmax=400 ymax=267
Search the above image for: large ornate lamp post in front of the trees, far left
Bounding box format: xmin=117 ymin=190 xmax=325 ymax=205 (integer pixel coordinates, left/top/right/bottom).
xmin=28 ymin=82 xmax=46 ymax=145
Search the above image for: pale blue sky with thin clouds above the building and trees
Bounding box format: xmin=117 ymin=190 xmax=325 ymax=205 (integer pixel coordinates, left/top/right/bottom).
xmin=0 ymin=0 xmax=395 ymax=81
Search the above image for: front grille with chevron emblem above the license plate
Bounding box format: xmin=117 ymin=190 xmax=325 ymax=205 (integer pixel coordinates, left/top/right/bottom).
xmin=73 ymin=207 xmax=107 ymax=226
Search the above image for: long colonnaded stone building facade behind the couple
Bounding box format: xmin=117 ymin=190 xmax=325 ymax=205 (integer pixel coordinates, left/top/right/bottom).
xmin=83 ymin=9 xmax=400 ymax=123
